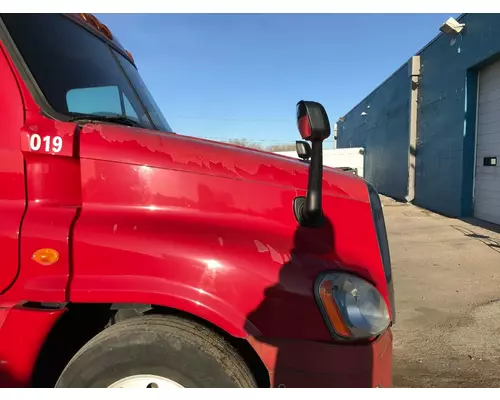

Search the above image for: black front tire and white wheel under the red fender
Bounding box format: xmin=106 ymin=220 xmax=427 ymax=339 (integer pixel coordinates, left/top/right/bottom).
xmin=56 ymin=315 xmax=257 ymax=388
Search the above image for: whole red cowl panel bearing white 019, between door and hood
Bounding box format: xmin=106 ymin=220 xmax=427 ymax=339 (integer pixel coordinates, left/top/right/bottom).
xmin=1 ymin=115 xmax=81 ymax=304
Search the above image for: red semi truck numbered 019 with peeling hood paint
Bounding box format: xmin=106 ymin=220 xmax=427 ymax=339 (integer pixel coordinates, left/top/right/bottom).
xmin=0 ymin=14 xmax=395 ymax=388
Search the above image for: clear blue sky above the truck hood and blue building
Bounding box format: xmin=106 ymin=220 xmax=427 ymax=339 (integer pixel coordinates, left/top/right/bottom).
xmin=97 ymin=14 xmax=457 ymax=148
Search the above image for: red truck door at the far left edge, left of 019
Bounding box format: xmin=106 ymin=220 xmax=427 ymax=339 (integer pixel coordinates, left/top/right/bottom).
xmin=0 ymin=42 xmax=26 ymax=293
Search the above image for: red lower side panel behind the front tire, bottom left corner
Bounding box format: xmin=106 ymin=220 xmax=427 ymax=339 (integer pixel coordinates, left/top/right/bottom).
xmin=0 ymin=307 xmax=65 ymax=388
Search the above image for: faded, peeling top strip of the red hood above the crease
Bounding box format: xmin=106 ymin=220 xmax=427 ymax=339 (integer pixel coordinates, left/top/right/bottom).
xmin=80 ymin=124 xmax=368 ymax=202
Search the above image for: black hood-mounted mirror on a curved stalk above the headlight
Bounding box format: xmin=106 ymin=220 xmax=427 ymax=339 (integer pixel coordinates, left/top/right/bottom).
xmin=293 ymin=100 xmax=331 ymax=227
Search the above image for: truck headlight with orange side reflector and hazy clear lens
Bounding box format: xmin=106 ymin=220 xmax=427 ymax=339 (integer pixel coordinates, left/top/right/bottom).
xmin=315 ymin=272 xmax=391 ymax=339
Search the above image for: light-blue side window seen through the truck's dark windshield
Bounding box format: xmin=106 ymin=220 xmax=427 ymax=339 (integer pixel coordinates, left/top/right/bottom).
xmin=66 ymin=86 xmax=139 ymax=121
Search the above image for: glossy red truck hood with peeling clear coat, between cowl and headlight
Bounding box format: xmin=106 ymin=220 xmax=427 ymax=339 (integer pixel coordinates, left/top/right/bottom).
xmin=70 ymin=125 xmax=387 ymax=340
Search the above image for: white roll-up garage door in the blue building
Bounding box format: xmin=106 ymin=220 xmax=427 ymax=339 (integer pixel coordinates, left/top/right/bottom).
xmin=474 ymin=62 xmax=500 ymax=224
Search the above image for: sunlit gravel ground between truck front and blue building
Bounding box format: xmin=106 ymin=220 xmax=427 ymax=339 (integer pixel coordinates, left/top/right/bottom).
xmin=383 ymin=198 xmax=500 ymax=387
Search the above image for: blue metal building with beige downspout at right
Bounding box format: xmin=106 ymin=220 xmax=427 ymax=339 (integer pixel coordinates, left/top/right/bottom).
xmin=337 ymin=14 xmax=500 ymax=224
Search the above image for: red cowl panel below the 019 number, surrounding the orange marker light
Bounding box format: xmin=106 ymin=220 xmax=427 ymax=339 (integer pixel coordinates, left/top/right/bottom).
xmin=19 ymin=148 xmax=81 ymax=302
